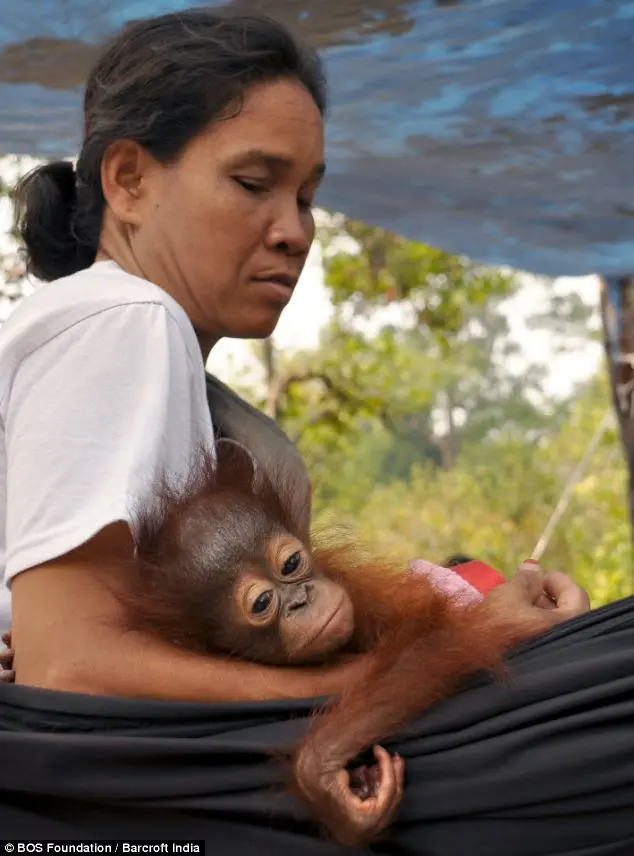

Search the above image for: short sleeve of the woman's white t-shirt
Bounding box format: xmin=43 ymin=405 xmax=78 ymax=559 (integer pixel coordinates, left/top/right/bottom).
xmin=5 ymin=303 xmax=213 ymax=580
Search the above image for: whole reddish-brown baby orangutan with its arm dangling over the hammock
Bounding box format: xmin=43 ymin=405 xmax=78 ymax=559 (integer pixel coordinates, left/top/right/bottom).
xmin=118 ymin=441 xmax=553 ymax=847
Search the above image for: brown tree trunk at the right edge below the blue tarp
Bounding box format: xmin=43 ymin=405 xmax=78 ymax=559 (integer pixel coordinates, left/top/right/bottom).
xmin=601 ymin=276 xmax=634 ymax=552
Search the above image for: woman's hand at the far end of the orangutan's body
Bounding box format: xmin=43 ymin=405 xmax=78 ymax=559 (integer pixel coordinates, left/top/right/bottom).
xmin=485 ymin=562 xmax=590 ymax=625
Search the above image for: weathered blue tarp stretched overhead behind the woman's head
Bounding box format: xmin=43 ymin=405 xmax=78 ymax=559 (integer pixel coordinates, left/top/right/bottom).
xmin=0 ymin=0 xmax=634 ymax=275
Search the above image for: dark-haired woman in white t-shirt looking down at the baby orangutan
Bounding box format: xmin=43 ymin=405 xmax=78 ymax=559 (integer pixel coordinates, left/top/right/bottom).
xmin=0 ymin=10 xmax=585 ymax=701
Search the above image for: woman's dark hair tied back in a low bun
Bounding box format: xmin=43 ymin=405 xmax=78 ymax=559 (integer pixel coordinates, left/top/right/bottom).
xmin=16 ymin=9 xmax=326 ymax=281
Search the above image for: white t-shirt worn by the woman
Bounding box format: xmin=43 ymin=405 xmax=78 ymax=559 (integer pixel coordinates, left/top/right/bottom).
xmin=0 ymin=262 xmax=213 ymax=630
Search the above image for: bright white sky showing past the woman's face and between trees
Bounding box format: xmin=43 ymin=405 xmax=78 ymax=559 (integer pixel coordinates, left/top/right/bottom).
xmin=0 ymin=156 xmax=602 ymax=396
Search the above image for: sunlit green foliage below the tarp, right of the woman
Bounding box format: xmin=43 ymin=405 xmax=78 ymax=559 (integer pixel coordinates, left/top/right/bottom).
xmin=249 ymin=218 xmax=633 ymax=604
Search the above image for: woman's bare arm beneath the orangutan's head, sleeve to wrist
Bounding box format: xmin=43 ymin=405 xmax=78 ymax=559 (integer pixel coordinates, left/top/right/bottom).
xmin=12 ymin=524 xmax=361 ymax=702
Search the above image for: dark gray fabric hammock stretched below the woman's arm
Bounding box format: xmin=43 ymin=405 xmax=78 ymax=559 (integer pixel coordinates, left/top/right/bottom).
xmin=0 ymin=598 xmax=634 ymax=856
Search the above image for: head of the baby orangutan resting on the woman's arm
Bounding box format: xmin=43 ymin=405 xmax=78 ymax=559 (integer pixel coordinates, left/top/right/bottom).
xmin=119 ymin=440 xmax=354 ymax=666
